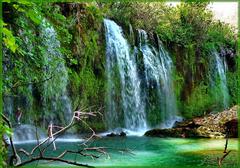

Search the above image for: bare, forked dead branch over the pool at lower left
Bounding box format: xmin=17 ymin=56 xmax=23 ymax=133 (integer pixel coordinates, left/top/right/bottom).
xmin=2 ymin=108 xmax=128 ymax=167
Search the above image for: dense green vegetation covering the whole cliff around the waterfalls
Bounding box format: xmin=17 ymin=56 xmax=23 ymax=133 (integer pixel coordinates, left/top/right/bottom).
xmin=1 ymin=0 xmax=239 ymax=166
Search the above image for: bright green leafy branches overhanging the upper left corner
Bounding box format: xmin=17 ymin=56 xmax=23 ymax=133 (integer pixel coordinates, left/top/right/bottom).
xmin=3 ymin=1 xmax=47 ymax=95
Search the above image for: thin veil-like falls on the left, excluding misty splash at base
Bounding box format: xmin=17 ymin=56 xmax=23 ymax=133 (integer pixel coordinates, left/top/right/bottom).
xmin=3 ymin=19 xmax=72 ymax=128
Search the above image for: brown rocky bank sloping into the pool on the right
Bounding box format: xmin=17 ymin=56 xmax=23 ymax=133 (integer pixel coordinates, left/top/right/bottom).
xmin=145 ymin=106 xmax=238 ymax=138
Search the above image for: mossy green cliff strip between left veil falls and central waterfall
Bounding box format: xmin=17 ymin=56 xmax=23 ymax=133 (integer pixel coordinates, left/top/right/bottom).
xmin=66 ymin=3 xmax=105 ymax=114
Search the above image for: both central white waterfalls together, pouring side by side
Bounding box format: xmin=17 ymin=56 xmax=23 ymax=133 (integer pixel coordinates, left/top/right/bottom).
xmin=104 ymin=19 xmax=179 ymax=131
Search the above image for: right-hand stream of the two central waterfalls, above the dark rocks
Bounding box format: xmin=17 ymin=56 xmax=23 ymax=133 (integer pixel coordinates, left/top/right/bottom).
xmin=138 ymin=30 xmax=178 ymax=128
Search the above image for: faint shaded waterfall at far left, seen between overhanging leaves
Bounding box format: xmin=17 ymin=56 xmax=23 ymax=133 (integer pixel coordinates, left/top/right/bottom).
xmin=3 ymin=22 xmax=34 ymax=124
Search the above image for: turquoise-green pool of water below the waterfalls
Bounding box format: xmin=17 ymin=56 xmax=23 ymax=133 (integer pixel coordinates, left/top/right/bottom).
xmin=17 ymin=137 xmax=238 ymax=168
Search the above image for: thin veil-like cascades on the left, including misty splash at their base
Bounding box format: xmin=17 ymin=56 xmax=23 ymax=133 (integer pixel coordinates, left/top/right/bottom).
xmin=4 ymin=19 xmax=72 ymax=141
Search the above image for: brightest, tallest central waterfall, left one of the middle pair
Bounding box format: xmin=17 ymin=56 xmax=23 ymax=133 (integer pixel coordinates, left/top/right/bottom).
xmin=104 ymin=19 xmax=147 ymax=130
